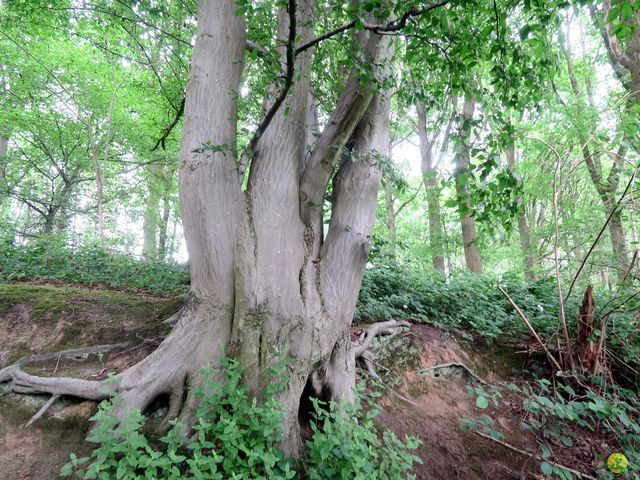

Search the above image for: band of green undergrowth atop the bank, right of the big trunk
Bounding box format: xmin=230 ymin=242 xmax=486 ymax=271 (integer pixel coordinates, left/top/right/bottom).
xmin=356 ymin=265 xmax=640 ymax=383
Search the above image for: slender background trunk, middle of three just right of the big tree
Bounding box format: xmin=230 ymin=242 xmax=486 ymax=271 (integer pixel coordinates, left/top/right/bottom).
xmin=455 ymin=95 xmax=482 ymax=273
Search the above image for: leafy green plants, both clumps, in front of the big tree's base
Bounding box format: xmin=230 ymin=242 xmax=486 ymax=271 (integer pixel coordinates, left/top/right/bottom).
xmin=61 ymin=358 xmax=420 ymax=480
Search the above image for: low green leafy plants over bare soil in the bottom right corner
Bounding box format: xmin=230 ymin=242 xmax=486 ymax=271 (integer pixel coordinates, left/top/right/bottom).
xmin=462 ymin=378 xmax=640 ymax=480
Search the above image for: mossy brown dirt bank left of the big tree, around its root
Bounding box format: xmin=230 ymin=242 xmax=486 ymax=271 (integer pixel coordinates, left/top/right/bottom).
xmin=0 ymin=284 xmax=180 ymax=480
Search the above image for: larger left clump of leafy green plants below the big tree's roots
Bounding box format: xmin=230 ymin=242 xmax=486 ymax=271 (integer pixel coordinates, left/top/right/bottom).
xmin=61 ymin=358 xmax=295 ymax=480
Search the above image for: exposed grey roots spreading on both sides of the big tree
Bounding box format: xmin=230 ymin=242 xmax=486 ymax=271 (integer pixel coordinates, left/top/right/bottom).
xmin=0 ymin=316 xmax=410 ymax=430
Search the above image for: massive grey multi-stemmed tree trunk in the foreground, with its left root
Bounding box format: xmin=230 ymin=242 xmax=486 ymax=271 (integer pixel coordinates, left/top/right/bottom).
xmin=0 ymin=0 xmax=392 ymax=456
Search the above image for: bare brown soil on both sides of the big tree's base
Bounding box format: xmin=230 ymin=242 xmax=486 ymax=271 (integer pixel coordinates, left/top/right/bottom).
xmin=0 ymin=284 xmax=608 ymax=480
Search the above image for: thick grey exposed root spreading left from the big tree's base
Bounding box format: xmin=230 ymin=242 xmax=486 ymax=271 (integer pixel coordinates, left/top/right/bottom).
xmin=0 ymin=304 xmax=230 ymax=429
